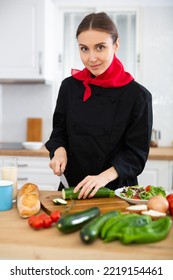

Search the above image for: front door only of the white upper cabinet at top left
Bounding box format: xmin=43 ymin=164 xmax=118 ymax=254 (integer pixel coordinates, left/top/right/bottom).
xmin=0 ymin=0 xmax=44 ymax=79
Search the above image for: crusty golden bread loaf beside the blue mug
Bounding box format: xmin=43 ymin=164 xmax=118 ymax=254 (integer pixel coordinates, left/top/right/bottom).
xmin=17 ymin=183 xmax=41 ymax=218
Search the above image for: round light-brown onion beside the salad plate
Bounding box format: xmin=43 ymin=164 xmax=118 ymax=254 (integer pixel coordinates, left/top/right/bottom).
xmin=147 ymin=195 xmax=169 ymax=213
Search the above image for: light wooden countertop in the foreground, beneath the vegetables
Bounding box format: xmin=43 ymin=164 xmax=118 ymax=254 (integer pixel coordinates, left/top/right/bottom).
xmin=0 ymin=192 xmax=173 ymax=260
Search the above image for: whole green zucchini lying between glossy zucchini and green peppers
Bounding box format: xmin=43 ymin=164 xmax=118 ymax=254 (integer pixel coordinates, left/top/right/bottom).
xmin=80 ymin=211 xmax=119 ymax=243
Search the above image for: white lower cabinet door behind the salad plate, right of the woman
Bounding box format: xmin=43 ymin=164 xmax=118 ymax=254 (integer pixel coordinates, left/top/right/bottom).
xmin=138 ymin=160 xmax=171 ymax=191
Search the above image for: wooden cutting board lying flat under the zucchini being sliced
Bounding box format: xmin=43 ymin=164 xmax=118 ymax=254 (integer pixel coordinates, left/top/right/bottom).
xmin=40 ymin=191 xmax=129 ymax=214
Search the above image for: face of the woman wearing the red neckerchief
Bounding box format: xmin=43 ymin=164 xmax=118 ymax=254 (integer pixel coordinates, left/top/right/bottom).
xmin=77 ymin=29 xmax=119 ymax=76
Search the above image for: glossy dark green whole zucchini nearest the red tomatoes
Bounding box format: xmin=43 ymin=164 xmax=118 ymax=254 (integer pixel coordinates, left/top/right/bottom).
xmin=56 ymin=207 xmax=100 ymax=233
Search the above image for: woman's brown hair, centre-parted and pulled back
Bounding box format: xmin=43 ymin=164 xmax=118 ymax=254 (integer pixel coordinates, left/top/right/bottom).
xmin=76 ymin=12 xmax=118 ymax=43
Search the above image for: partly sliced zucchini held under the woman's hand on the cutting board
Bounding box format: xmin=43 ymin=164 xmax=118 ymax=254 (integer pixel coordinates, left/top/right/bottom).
xmin=62 ymin=187 xmax=115 ymax=199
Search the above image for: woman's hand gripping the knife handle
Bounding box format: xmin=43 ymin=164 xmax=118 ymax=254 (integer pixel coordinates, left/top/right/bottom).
xmin=49 ymin=147 xmax=67 ymax=176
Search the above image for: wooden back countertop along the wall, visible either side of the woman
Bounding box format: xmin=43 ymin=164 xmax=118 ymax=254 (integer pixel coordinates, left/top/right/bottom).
xmin=0 ymin=146 xmax=173 ymax=160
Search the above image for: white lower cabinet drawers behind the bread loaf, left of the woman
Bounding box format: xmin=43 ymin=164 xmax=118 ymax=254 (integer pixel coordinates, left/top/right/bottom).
xmin=0 ymin=156 xmax=60 ymax=191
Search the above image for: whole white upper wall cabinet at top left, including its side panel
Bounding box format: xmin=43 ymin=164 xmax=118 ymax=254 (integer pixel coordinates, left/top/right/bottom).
xmin=0 ymin=0 xmax=54 ymax=81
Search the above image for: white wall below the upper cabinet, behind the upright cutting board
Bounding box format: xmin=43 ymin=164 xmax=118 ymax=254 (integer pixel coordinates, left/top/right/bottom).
xmin=2 ymin=84 xmax=52 ymax=142
